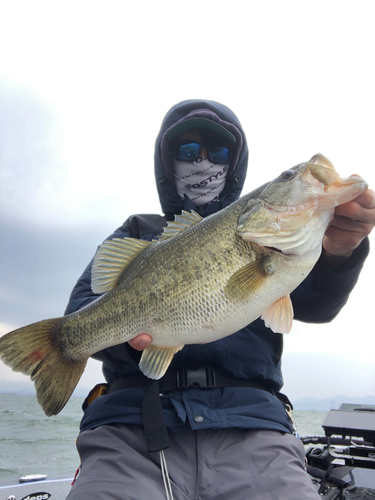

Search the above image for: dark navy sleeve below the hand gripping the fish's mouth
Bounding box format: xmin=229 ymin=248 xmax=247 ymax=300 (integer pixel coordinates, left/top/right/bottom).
xmin=291 ymin=238 xmax=370 ymax=323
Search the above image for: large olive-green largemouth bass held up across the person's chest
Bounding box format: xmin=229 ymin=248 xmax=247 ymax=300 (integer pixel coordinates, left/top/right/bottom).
xmin=0 ymin=153 xmax=367 ymax=416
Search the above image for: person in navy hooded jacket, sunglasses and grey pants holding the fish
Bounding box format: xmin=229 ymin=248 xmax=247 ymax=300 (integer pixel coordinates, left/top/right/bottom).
xmin=66 ymin=100 xmax=375 ymax=500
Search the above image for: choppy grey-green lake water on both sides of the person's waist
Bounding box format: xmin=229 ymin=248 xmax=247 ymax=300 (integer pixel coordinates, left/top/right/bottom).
xmin=0 ymin=394 xmax=327 ymax=485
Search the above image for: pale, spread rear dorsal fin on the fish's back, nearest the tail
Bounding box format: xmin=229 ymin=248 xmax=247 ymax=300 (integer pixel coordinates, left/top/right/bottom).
xmin=91 ymin=238 xmax=152 ymax=293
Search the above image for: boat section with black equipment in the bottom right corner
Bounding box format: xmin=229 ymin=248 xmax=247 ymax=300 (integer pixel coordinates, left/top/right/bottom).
xmin=306 ymin=404 xmax=375 ymax=500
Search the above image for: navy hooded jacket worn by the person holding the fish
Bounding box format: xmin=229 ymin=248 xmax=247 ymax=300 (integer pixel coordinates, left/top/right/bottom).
xmin=66 ymin=100 xmax=368 ymax=432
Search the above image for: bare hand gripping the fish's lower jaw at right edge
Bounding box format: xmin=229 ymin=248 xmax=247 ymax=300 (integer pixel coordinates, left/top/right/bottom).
xmin=322 ymin=189 xmax=375 ymax=268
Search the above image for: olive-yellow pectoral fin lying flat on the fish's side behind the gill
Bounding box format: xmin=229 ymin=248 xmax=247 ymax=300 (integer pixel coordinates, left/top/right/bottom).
xmin=224 ymin=255 xmax=274 ymax=300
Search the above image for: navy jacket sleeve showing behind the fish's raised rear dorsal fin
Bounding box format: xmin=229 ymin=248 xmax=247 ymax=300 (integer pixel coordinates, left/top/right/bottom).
xmin=64 ymin=223 xmax=132 ymax=315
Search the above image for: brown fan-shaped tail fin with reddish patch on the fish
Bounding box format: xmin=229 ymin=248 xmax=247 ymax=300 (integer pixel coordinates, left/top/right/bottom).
xmin=0 ymin=318 xmax=87 ymax=417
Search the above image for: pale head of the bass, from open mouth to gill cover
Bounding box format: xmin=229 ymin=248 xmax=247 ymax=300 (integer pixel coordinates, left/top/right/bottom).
xmin=236 ymin=154 xmax=367 ymax=256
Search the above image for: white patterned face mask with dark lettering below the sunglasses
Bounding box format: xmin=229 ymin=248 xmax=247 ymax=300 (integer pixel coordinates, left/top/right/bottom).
xmin=173 ymin=158 xmax=228 ymax=207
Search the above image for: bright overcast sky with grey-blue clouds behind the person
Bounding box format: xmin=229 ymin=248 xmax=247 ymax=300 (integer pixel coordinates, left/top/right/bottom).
xmin=0 ymin=0 xmax=375 ymax=401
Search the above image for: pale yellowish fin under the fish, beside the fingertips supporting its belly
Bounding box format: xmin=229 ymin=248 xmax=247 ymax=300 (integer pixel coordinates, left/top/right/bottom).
xmin=139 ymin=344 xmax=184 ymax=380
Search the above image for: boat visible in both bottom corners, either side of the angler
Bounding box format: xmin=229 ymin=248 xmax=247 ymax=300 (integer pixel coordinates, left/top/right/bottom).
xmin=0 ymin=404 xmax=375 ymax=500
